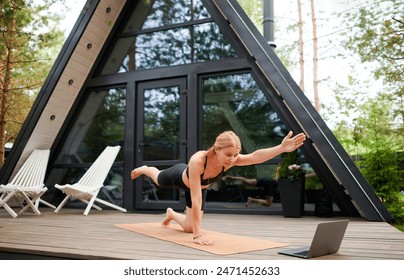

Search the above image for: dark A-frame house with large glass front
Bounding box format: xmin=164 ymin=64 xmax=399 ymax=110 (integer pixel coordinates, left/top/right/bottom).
xmin=0 ymin=0 xmax=392 ymax=221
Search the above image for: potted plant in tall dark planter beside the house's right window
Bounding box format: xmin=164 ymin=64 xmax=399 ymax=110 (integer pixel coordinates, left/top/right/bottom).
xmin=278 ymin=151 xmax=305 ymax=218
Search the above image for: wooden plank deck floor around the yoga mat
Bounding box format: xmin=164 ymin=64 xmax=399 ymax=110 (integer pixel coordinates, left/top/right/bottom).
xmin=0 ymin=208 xmax=404 ymax=260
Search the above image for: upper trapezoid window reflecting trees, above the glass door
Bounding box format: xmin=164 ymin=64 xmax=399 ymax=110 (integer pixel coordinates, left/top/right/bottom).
xmin=100 ymin=0 xmax=237 ymax=75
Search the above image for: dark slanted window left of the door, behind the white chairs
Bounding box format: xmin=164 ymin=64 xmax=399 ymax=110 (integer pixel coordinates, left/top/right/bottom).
xmin=46 ymin=88 xmax=126 ymax=207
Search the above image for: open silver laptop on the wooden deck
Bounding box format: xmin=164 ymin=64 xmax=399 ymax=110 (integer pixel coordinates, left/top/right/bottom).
xmin=278 ymin=220 xmax=349 ymax=259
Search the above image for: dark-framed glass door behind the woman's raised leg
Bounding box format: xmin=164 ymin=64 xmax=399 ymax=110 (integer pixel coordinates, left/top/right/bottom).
xmin=135 ymin=78 xmax=187 ymax=210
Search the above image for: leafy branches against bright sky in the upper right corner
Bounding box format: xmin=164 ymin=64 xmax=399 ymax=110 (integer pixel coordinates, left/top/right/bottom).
xmin=346 ymin=0 xmax=404 ymax=131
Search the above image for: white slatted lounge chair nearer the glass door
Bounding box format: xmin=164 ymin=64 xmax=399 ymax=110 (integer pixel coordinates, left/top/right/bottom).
xmin=55 ymin=146 xmax=126 ymax=216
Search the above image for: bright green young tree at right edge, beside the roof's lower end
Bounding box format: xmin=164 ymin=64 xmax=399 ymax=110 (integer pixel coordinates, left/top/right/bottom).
xmin=358 ymin=95 xmax=404 ymax=223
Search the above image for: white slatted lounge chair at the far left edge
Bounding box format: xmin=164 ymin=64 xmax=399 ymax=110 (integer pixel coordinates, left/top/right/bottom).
xmin=0 ymin=149 xmax=51 ymax=218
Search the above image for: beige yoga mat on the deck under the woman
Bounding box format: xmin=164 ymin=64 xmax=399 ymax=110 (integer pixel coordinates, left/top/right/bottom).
xmin=114 ymin=223 xmax=288 ymax=255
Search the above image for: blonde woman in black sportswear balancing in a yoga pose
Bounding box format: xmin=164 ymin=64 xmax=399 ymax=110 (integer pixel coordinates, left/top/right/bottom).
xmin=131 ymin=131 xmax=306 ymax=245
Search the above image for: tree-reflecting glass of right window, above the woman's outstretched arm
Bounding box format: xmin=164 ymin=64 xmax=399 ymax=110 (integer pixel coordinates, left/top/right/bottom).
xmin=202 ymin=73 xmax=285 ymax=153
